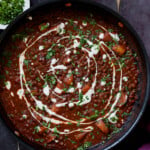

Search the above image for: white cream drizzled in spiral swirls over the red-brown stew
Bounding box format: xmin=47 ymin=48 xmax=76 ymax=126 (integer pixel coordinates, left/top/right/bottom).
xmin=17 ymin=19 xmax=122 ymax=134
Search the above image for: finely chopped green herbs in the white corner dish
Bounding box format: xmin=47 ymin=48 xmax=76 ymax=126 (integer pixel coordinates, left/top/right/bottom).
xmin=0 ymin=0 xmax=24 ymax=24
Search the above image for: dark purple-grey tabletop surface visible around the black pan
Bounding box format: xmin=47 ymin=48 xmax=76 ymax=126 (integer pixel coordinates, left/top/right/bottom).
xmin=0 ymin=0 xmax=150 ymax=150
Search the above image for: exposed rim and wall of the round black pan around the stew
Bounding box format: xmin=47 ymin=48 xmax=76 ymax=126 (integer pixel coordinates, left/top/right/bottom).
xmin=0 ymin=0 xmax=150 ymax=150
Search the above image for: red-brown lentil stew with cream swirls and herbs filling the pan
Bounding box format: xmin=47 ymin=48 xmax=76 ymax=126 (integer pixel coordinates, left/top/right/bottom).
xmin=1 ymin=5 xmax=139 ymax=150
